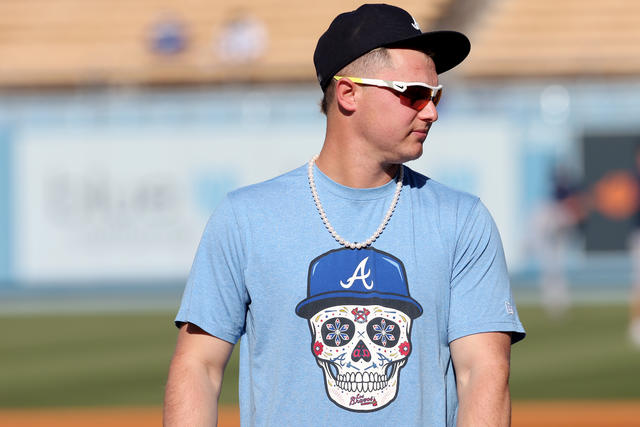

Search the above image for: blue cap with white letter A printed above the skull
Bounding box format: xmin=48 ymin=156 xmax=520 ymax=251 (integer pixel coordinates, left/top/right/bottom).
xmin=296 ymin=248 xmax=422 ymax=319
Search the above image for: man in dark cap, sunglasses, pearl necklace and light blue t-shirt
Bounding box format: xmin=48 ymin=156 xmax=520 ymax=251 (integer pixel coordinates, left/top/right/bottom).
xmin=165 ymin=4 xmax=524 ymax=426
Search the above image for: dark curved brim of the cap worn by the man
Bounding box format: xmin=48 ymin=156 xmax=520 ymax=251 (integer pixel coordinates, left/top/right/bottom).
xmin=385 ymin=31 xmax=471 ymax=74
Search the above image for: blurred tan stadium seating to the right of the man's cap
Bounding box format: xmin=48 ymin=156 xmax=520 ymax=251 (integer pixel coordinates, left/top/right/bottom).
xmin=464 ymin=0 xmax=640 ymax=77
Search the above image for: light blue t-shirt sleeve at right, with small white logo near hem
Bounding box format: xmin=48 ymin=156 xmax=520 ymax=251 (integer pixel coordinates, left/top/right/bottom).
xmin=449 ymin=200 xmax=525 ymax=343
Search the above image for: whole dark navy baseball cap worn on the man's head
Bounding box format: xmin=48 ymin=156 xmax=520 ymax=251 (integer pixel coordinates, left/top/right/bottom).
xmin=313 ymin=4 xmax=471 ymax=91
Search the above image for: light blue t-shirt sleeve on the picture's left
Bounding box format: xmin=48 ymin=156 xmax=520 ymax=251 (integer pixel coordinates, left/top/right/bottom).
xmin=175 ymin=196 xmax=249 ymax=344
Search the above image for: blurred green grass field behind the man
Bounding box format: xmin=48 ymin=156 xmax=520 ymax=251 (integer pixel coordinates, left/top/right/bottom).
xmin=0 ymin=304 xmax=640 ymax=408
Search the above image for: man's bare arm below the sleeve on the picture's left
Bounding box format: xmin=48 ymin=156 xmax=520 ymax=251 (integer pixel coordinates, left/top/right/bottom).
xmin=163 ymin=323 xmax=233 ymax=427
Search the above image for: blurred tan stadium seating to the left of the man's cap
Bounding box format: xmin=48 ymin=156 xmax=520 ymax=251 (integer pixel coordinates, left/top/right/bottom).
xmin=0 ymin=0 xmax=451 ymax=87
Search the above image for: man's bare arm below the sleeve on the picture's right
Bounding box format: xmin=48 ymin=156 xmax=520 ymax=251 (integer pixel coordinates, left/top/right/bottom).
xmin=449 ymin=332 xmax=511 ymax=427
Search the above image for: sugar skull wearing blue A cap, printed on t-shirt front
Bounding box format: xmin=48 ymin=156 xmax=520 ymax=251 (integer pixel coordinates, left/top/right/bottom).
xmin=296 ymin=248 xmax=422 ymax=412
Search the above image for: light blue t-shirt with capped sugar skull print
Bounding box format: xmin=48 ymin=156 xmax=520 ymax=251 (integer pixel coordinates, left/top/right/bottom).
xmin=176 ymin=166 xmax=524 ymax=426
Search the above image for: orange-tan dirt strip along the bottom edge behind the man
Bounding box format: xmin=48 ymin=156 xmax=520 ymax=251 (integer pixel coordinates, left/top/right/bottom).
xmin=0 ymin=401 xmax=640 ymax=427
